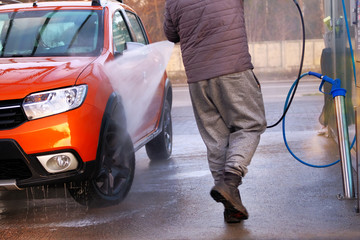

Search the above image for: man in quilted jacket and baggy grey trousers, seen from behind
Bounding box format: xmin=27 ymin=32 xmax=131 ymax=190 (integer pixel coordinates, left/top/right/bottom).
xmin=164 ymin=0 xmax=266 ymax=223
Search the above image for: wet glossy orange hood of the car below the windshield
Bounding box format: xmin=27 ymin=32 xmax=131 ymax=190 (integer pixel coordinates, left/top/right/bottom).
xmin=0 ymin=57 xmax=96 ymax=100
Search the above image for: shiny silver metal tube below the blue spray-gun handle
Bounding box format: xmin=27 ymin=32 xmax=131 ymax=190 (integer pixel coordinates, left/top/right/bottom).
xmin=334 ymin=95 xmax=355 ymax=199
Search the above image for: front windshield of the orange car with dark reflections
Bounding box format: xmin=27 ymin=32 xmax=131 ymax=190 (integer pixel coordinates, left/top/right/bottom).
xmin=0 ymin=10 xmax=103 ymax=58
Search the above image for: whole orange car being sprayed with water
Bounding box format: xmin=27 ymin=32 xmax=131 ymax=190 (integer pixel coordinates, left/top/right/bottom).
xmin=0 ymin=0 xmax=172 ymax=207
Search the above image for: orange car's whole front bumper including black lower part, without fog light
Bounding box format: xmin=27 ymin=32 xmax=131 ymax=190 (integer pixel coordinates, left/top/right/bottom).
xmin=0 ymin=104 xmax=103 ymax=189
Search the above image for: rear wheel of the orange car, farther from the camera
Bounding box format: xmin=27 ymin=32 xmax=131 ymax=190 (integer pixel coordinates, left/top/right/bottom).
xmin=145 ymin=100 xmax=172 ymax=161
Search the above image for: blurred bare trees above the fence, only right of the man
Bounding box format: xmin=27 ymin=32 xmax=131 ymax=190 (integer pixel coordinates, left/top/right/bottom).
xmin=245 ymin=0 xmax=323 ymax=41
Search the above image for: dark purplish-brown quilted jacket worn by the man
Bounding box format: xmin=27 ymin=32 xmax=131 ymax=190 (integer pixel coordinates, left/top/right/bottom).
xmin=164 ymin=0 xmax=253 ymax=83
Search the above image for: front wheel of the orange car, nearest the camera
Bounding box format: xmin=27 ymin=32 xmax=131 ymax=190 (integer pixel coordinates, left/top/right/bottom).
xmin=68 ymin=100 xmax=135 ymax=207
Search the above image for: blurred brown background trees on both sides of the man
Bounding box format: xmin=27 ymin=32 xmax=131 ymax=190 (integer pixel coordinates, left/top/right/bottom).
xmin=125 ymin=0 xmax=323 ymax=42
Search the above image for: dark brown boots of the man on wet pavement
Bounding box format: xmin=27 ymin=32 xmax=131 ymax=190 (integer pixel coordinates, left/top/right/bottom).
xmin=210 ymin=173 xmax=249 ymax=223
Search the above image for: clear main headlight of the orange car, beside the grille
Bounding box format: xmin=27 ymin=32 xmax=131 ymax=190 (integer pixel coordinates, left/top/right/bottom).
xmin=23 ymin=85 xmax=87 ymax=120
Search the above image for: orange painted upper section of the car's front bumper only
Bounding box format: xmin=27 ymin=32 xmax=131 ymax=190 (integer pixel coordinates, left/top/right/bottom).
xmin=0 ymin=103 xmax=105 ymax=162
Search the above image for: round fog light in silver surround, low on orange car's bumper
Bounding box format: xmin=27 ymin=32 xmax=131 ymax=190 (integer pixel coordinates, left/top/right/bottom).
xmin=37 ymin=152 xmax=78 ymax=173
